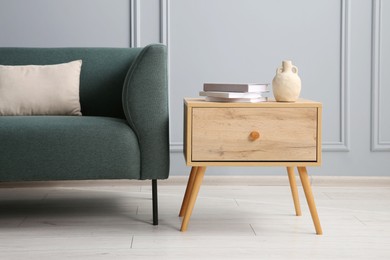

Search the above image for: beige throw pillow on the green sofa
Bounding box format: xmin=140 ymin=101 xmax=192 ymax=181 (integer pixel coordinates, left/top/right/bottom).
xmin=0 ymin=60 xmax=82 ymax=116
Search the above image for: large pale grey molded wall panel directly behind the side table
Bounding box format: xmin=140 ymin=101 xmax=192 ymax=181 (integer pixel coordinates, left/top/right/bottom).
xmin=170 ymin=0 xmax=348 ymax=149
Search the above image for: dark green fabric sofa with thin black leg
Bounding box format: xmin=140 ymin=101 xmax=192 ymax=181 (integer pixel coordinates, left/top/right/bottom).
xmin=0 ymin=44 xmax=169 ymax=225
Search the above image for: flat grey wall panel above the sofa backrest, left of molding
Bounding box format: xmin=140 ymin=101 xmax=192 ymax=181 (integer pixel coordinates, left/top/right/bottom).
xmin=0 ymin=0 xmax=130 ymax=47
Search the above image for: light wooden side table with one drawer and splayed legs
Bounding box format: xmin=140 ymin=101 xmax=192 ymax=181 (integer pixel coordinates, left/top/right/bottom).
xmin=179 ymin=98 xmax=322 ymax=235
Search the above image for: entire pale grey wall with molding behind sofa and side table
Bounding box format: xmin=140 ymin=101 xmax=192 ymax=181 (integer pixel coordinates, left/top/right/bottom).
xmin=0 ymin=0 xmax=390 ymax=176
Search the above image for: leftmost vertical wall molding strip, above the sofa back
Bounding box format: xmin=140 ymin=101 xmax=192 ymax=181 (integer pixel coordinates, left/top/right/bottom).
xmin=130 ymin=0 xmax=141 ymax=48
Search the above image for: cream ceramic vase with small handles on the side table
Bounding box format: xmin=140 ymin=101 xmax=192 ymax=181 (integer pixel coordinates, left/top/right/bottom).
xmin=272 ymin=60 xmax=301 ymax=102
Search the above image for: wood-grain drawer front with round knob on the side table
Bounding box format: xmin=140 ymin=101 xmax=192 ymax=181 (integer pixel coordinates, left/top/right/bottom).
xmin=191 ymin=107 xmax=318 ymax=162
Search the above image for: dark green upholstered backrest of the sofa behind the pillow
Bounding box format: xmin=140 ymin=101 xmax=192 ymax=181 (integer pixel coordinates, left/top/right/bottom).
xmin=0 ymin=48 xmax=142 ymax=118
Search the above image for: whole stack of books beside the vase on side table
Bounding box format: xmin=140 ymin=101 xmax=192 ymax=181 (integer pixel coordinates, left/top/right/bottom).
xmin=199 ymin=83 xmax=269 ymax=103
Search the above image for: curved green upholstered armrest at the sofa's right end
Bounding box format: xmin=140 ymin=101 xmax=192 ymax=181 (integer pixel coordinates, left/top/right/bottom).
xmin=122 ymin=44 xmax=169 ymax=179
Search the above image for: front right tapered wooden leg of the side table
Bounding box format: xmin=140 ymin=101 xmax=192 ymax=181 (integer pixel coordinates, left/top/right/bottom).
xmin=298 ymin=167 xmax=322 ymax=235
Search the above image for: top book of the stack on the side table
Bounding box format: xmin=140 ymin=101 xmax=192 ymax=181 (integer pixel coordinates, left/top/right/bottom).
xmin=203 ymin=83 xmax=269 ymax=92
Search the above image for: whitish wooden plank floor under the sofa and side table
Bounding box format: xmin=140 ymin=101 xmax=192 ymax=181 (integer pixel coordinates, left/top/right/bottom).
xmin=0 ymin=176 xmax=390 ymax=260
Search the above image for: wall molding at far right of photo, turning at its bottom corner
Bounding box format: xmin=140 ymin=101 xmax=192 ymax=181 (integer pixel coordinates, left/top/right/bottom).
xmin=371 ymin=0 xmax=390 ymax=152
